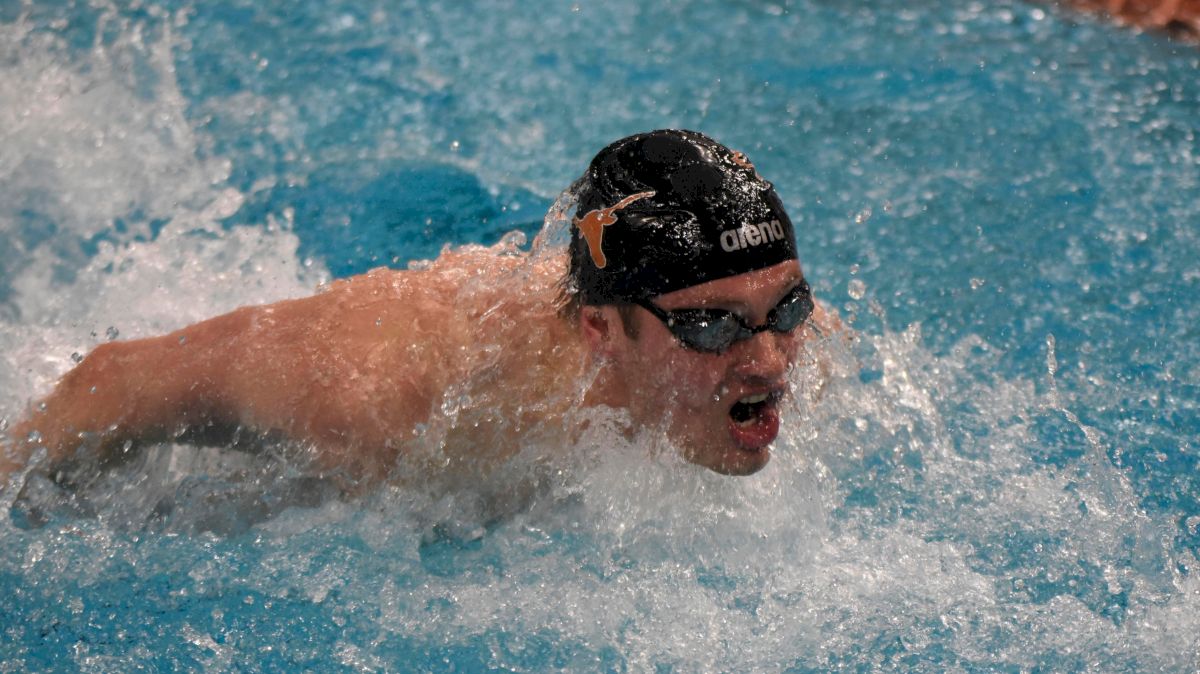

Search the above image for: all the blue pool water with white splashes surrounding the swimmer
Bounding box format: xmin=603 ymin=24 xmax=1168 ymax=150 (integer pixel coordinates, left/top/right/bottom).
xmin=0 ymin=0 xmax=1200 ymax=672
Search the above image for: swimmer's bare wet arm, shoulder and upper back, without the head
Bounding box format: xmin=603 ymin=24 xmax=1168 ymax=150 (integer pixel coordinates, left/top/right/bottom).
xmin=0 ymin=247 xmax=586 ymax=483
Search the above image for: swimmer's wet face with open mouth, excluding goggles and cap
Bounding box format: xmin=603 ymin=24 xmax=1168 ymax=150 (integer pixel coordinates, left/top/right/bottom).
xmin=597 ymin=260 xmax=811 ymax=475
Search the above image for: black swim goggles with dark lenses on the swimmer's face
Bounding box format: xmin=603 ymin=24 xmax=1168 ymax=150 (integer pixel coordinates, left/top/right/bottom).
xmin=634 ymin=279 xmax=814 ymax=354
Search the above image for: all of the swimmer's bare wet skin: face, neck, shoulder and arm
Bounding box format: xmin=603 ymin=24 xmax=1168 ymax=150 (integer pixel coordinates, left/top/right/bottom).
xmin=0 ymin=247 xmax=824 ymax=486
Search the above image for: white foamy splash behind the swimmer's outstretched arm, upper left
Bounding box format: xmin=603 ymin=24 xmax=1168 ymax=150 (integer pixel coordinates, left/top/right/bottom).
xmin=0 ymin=7 xmax=325 ymax=416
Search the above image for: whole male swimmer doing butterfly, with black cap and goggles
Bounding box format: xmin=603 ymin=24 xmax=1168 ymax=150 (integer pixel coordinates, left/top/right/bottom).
xmin=0 ymin=131 xmax=836 ymax=483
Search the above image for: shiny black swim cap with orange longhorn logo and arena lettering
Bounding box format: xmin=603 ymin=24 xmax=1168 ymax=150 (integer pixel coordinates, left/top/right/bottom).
xmin=571 ymin=130 xmax=797 ymax=305
